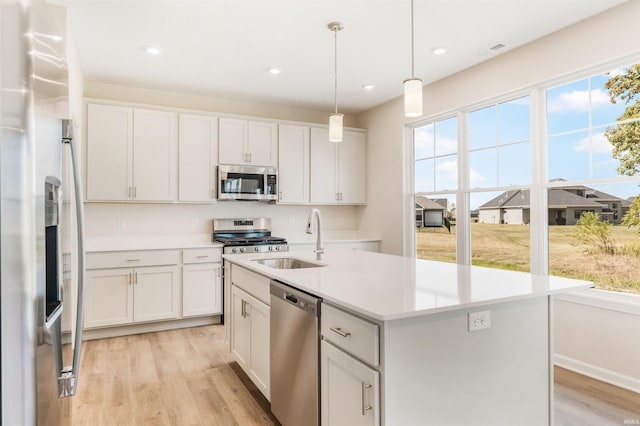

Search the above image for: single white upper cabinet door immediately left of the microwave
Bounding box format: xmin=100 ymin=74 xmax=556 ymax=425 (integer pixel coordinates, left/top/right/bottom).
xmin=178 ymin=114 xmax=218 ymax=202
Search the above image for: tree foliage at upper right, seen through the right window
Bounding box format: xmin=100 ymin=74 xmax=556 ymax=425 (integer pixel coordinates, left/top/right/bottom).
xmin=605 ymin=64 xmax=640 ymax=176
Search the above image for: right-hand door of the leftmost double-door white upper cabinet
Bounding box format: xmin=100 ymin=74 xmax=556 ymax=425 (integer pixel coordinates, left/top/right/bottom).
xmin=133 ymin=109 xmax=178 ymax=201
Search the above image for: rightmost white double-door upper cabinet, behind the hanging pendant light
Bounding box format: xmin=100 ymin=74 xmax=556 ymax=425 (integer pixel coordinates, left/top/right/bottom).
xmin=310 ymin=128 xmax=366 ymax=204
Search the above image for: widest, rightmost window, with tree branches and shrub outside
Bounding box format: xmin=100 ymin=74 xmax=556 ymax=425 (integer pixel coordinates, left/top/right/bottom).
xmin=546 ymin=65 xmax=640 ymax=293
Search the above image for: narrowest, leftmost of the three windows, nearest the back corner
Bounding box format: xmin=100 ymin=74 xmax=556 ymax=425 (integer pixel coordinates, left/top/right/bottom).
xmin=413 ymin=117 xmax=458 ymax=262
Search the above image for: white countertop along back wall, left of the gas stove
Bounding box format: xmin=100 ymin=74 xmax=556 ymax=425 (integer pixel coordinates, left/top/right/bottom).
xmin=85 ymin=234 xmax=222 ymax=253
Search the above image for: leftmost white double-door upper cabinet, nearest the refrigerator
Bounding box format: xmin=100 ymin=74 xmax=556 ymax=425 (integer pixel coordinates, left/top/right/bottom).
xmin=87 ymin=104 xmax=178 ymax=201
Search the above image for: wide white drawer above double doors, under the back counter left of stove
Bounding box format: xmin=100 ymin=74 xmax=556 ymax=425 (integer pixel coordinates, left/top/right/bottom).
xmin=86 ymin=250 xmax=180 ymax=269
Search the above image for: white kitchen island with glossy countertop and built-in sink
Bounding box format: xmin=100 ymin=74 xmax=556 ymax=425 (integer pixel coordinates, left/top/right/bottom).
xmin=225 ymin=250 xmax=593 ymax=426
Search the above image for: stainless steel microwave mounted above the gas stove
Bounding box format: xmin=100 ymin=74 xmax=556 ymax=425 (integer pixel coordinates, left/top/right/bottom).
xmin=218 ymin=166 xmax=278 ymax=201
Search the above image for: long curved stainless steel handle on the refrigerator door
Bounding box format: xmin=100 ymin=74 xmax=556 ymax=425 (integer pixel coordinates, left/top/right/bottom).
xmin=58 ymin=120 xmax=85 ymax=398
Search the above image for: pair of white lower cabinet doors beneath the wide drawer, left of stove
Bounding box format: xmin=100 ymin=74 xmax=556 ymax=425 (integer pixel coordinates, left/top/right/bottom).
xmin=84 ymin=265 xmax=179 ymax=328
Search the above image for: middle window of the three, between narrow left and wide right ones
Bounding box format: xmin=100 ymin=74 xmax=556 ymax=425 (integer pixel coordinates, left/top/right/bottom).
xmin=468 ymin=96 xmax=531 ymax=271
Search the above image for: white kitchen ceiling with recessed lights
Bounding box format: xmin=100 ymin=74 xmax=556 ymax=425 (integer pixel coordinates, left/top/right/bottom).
xmin=57 ymin=0 xmax=624 ymax=114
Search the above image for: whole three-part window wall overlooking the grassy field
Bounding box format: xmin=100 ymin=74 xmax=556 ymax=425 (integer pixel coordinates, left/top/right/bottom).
xmin=413 ymin=60 xmax=640 ymax=294
